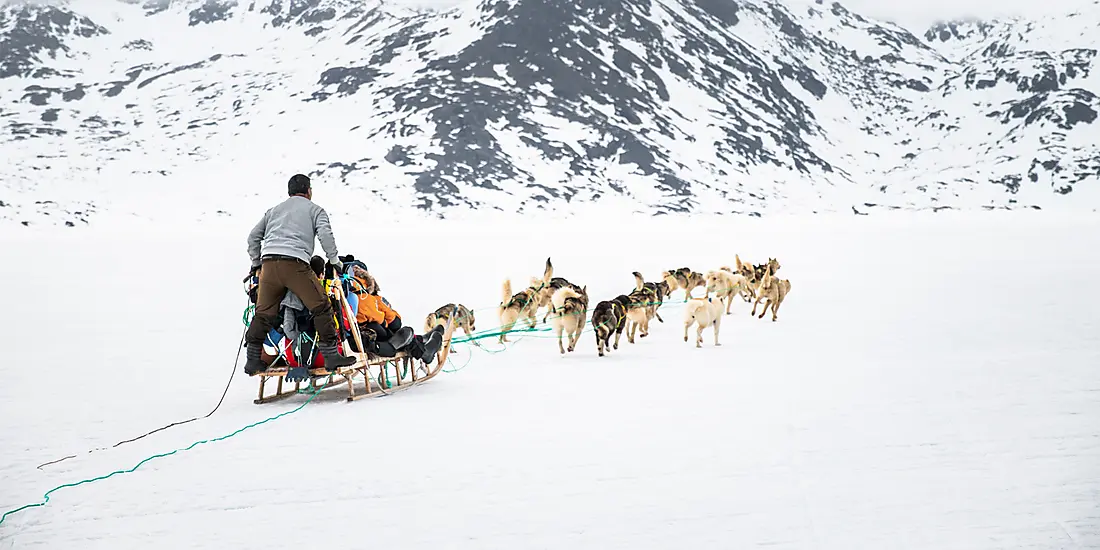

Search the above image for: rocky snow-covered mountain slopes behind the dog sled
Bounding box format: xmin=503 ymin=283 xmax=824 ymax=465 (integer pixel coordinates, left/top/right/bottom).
xmin=0 ymin=0 xmax=1100 ymax=224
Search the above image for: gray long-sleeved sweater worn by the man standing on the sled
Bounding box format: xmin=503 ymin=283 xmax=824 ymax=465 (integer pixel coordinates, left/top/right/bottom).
xmin=249 ymin=196 xmax=339 ymax=265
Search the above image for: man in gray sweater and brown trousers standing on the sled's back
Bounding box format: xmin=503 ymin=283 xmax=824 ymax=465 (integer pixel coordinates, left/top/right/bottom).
xmin=244 ymin=174 xmax=355 ymax=376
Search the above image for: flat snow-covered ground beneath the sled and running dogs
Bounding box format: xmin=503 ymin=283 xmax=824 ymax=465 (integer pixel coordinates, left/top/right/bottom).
xmin=0 ymin=209 xmax=1100 ymax=550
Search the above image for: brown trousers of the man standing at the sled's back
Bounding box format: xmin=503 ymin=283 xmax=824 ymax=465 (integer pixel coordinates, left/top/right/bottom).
xmin=244 ymin=259 xmax=338 ymax=347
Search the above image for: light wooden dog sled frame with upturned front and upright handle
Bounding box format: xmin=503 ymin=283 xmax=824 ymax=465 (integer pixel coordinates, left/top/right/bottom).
xmin=252 ymin=272 xmax=455 ymax=405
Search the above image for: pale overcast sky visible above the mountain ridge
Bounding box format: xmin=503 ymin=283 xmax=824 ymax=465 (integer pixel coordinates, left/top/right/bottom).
xmin=388 ymin=0 xmax=1100 ymax=32
